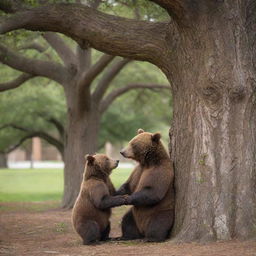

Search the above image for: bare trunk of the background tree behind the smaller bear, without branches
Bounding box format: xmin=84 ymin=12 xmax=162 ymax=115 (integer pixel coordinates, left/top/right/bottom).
xmin=62 ymin=86 xmax=100 ymax=208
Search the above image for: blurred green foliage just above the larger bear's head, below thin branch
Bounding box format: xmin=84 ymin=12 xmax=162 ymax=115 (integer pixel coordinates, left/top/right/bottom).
xmin=99 ymin=85 xmax=172 ymax=148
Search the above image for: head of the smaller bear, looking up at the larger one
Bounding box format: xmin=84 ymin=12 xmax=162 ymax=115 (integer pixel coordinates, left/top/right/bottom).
xmin=85 ymin=154 xmax=119 ymax=178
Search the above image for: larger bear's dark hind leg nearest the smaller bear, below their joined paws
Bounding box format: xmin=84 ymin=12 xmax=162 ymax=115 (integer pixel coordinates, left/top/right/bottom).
xmin=121 ymin=210 xmax=143 ymax=240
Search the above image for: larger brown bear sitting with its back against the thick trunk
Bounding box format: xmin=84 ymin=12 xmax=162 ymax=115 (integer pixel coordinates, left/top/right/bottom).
xmin=117 ymin=129 xmax=174 ymax=242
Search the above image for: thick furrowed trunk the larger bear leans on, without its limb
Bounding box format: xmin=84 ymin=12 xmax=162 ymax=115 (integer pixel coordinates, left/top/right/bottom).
xmin=169 ymin=1 xmax=256 ymax=241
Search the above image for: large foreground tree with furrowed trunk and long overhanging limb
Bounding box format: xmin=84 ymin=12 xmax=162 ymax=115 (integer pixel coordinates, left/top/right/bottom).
xmin=0 ymin=0 xmax=256 ymax=241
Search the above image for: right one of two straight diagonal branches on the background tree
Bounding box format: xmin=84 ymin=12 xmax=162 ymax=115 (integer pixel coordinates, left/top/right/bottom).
xmin=92 ymin=59 xmax=131 ymax=102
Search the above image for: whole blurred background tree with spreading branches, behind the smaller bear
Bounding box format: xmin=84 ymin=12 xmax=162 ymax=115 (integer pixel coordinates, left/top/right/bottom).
xmin=0 ymin=0 xmax=169 ymax=208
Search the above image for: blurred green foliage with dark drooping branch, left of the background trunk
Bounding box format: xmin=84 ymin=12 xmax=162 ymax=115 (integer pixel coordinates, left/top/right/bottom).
xmin=0 ymin=79 xmax=66 ymax=158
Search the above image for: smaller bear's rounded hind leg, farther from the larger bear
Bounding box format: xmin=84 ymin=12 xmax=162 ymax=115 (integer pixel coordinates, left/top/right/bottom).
xmin=77 ymin=220 xmax=101 ymax=245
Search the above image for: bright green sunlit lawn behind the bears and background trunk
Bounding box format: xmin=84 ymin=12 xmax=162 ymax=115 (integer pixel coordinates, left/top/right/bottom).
xmin=0 ymin=168 xmax=131 ymax=202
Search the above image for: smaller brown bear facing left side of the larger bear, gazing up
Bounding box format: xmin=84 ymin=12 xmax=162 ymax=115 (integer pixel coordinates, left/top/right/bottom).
xmin=72 ymin=154 xmax=126 ymax=244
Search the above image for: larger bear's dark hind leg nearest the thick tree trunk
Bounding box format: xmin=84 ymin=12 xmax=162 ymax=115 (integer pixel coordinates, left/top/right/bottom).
xmin=145 ymin=211 xmax=173 ymax=242
